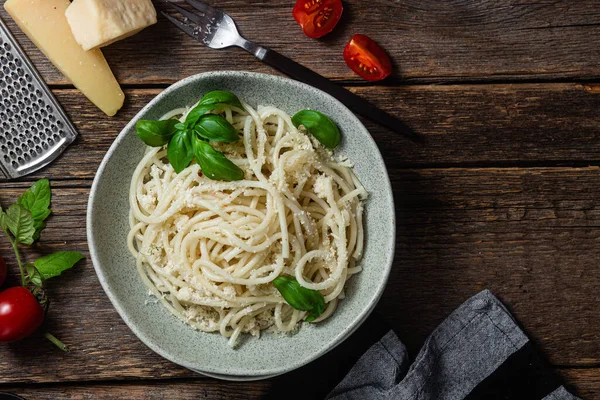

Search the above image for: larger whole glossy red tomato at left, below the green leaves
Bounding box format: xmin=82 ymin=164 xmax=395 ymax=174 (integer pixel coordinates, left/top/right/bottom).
xmin=0 ymin=286 xmax=44 ymax=342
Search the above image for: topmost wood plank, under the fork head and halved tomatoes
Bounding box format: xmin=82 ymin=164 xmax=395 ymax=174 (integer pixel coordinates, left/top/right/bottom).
xmin=0 ymin=0 xmax=600 ymax=85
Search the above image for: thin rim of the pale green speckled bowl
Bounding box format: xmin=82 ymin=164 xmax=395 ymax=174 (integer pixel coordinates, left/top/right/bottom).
xmin=86 ymin=70 xmax=396 ymax=381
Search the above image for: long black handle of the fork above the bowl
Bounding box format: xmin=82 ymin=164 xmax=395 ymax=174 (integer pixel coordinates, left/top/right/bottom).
xmin=253 ymin=46 xmax=417 ymax=140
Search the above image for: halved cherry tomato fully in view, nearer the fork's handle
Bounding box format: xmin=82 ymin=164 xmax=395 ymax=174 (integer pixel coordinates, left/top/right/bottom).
xmin=344 ymin=35 xmax=392 ymax=81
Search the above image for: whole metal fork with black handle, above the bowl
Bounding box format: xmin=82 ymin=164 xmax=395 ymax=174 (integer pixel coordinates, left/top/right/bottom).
xmin=162 ymin=0 xmax=417 ymax=139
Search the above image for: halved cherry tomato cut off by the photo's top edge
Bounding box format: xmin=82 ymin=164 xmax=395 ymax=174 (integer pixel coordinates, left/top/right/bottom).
xmin=292 ymin=0 xmax=344 ymax=39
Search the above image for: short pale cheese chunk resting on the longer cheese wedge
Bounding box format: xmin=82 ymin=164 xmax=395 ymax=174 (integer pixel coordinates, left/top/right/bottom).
xmin=65 ymin=0 xmax=156 ymax=50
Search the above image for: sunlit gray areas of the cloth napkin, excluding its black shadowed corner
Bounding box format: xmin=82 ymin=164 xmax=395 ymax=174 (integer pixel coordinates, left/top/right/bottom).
xmin=327 ymin=290 xmax=576 ymax=400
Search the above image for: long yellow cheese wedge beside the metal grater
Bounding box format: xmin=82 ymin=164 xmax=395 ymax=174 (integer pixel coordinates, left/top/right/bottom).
xmin=4 ymin=0 xmax=125 ymax=116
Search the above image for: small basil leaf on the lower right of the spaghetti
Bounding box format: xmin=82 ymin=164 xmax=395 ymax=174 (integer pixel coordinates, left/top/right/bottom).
xmin=273 ymin=275 xmax=325 ymax=322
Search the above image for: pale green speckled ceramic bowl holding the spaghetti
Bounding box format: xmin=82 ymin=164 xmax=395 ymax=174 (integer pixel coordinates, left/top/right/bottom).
xmin=87 ymin=71 xmax=395 ymax=380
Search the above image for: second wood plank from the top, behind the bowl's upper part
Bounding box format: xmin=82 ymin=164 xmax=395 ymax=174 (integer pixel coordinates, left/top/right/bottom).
xmin=7 ymin=84 xmax=600 ymax=183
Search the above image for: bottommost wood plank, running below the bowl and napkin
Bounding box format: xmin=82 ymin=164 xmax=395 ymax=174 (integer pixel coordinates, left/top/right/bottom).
xmin=1 ymin=368 xmax=600 ymax=400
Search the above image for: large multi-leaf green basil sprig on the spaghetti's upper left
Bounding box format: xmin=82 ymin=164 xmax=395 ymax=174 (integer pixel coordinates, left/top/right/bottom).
xmin=136 ymin=90 xmax=244 ymax=181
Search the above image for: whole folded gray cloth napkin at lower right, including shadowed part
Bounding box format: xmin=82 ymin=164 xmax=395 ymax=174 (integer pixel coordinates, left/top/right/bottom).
xmin=327 ymin=290 xmax=577 ymax=400
